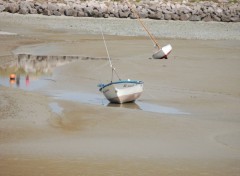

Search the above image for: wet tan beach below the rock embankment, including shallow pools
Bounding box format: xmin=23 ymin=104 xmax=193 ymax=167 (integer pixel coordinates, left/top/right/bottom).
xmin=0 ymin=13 xmax=240 ymax=176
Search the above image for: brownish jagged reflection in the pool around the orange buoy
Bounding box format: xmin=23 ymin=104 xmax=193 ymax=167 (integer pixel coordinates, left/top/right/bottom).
xmin=0 ymin=54 xmax=104 ymax=89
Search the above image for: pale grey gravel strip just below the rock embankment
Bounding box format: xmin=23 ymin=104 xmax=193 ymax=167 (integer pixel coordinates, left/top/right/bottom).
xmin=0 ymin=13 xmax=240 ymax=40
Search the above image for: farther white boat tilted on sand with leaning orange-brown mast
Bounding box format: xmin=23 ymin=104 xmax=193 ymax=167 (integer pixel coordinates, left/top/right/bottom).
xmin=126 ymin=0 xmax=172 ymax=59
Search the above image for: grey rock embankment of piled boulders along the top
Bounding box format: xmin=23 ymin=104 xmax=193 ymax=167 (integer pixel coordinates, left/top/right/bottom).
xmin=0 ymin=0 xmax=240 ymax=22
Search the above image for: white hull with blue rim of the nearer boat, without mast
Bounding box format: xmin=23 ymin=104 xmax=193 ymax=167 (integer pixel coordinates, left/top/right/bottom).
xmin=99 ymin=80 xmax=143 ymax=104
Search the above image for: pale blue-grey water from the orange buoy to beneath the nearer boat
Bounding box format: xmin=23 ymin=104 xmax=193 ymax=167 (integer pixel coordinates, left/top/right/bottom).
xmin=0 ymin=75 xmax=188 ymax=115
